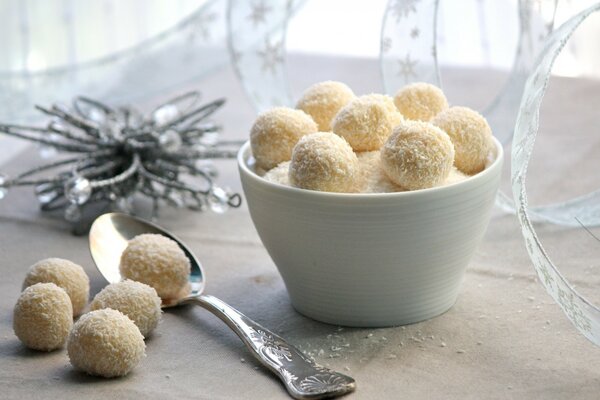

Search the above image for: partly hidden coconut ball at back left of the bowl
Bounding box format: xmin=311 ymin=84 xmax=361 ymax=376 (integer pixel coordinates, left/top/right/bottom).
xmin=296 ymin=81 xmax=354 ymax=132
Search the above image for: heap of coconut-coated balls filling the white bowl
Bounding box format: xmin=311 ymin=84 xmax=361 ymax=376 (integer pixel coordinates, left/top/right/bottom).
xmin=250 ymin=81 xmax=493 ymax=193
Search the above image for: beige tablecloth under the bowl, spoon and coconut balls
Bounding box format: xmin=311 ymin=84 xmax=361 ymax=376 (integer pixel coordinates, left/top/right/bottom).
xmin=0 ymin=57 xmax=600 ymax=400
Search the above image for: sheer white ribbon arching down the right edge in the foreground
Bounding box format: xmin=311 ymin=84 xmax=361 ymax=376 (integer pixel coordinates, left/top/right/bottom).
xmin=511 ymin=3 xmax=600 ymax=345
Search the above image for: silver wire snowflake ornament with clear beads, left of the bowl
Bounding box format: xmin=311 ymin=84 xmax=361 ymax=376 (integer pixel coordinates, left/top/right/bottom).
xmin=0 ymin=91 xmax=241 ymax=233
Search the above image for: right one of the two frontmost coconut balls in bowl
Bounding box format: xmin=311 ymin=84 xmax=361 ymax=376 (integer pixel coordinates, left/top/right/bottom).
xmin=381 ymin=121 xmax=454 ymax=190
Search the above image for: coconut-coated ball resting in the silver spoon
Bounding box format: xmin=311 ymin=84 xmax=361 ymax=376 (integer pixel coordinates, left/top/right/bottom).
xmin=120 ymin=233 xmax=191 ymax=303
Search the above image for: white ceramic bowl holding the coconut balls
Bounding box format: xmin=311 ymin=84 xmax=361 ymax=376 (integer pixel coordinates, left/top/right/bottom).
xmin=238 ymin=140 xmax=503 ymax=327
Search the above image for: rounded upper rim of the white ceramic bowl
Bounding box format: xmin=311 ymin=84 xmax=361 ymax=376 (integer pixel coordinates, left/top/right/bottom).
xmin=237 ymin=137 xmax=504 ymax=200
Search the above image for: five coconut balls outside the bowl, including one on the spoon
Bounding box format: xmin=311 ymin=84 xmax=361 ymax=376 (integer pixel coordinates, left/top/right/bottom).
xmin=13 ymin=234 xmax=190 ymax=378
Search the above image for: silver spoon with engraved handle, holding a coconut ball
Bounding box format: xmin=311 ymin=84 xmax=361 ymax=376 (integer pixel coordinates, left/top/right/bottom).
xmin=89 ymin=213 xmax=356 ymax=399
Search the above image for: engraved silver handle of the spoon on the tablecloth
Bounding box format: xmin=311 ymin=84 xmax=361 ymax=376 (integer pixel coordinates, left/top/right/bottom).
xmin=181 ymin=295 xmax=356 ymax=399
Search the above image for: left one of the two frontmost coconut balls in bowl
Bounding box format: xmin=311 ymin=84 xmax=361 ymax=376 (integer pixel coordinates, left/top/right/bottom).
xmin=289 ymin=132 xmax=360 ymax=192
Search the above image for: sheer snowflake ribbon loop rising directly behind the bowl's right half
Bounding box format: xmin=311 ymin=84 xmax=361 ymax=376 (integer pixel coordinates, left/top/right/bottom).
xmin=379 ymin=0 xmax=558 ymax=144
